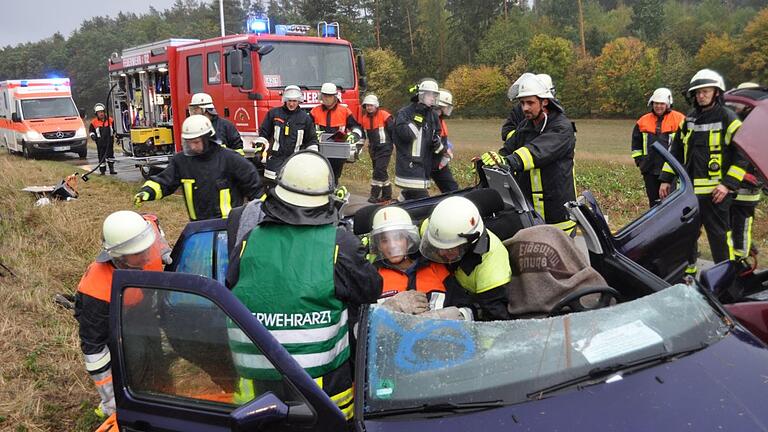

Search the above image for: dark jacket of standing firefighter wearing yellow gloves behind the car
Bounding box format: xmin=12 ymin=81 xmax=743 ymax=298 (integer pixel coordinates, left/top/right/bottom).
xmin=499 ymin=110 xmax=576 ymax=231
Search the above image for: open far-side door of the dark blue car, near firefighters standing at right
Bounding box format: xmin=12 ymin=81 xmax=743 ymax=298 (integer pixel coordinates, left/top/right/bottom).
xmin=582 ymin=143 xmax=700 ymax=282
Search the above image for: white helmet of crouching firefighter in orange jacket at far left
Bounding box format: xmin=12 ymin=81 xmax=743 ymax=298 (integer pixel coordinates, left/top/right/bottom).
xmin=102 ymin=210 xmax=155 ymax=258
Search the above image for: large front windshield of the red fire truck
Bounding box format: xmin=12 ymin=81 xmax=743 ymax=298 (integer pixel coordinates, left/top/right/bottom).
xmin=261 ymin=42 xmax=355 ymax=89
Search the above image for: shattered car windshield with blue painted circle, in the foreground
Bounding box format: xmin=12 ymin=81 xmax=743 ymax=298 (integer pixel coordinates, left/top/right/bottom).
xmin=364 ymin=284 xmax=729 ymax=415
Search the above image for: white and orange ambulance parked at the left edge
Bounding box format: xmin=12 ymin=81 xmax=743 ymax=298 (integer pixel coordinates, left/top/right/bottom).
xmin=0 ymin=78 xmax=88 ymax=158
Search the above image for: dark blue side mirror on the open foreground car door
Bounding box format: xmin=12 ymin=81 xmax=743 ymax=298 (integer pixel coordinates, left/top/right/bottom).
xmin=229 ymin=393 xmax=315 ymax=432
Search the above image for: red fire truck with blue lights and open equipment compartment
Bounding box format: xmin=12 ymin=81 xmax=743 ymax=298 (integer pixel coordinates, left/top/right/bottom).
xmin=109 ymin=20 xmax=366 ymax=176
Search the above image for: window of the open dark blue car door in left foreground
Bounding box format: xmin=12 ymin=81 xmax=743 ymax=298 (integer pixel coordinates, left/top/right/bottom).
xmin=120 ymin=287 xmax=300 ymax=411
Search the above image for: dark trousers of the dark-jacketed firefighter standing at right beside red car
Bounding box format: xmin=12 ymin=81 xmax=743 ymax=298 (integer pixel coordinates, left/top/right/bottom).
xmin=689 ymin=193 xmax=735 ymax=264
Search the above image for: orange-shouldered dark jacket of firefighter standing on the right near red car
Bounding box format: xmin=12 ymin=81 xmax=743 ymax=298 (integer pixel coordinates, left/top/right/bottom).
xmin=632 ymin=110 xmax=685 ymax=176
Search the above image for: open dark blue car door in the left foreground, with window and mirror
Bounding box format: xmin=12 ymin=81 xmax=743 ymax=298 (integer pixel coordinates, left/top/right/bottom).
xmin=110 ymin=270 xmax=345 ymax=432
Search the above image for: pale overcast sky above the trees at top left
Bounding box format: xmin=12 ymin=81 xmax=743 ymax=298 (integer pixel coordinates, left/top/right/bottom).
xmin=0 ymin=0 xmax=180 ymax=48
